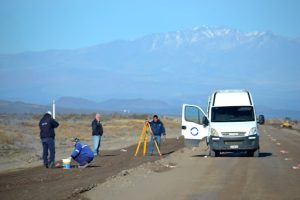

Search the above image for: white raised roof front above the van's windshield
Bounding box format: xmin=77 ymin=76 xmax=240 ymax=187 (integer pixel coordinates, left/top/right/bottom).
xmin=212 ymin=90 xmax=252 ymax=107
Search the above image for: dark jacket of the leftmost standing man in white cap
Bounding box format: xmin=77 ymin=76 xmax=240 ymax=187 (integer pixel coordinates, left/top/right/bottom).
xmin=39 ymin=113 xmax=59 ymax=138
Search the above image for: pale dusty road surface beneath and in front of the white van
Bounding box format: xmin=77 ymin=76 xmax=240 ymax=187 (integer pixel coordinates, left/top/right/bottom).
xmin=86 ymin=126 xmax=300 ymax=200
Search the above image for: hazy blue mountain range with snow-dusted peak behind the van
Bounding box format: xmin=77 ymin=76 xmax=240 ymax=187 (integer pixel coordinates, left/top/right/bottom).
xmin=0 ymin=27 xmax=300 ymax=115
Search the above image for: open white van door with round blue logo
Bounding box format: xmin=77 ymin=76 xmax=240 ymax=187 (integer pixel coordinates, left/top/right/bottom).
xmin=181 ymin=104 xmax=208 ymax=146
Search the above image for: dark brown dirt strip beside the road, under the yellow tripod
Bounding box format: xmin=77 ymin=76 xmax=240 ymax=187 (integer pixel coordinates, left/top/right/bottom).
xmin=0 ymin=139 xmax=183 ymax=200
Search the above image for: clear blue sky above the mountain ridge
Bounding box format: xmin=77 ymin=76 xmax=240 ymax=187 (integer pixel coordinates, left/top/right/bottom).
xmin=0 ymin=0 xmax=300 ymax=53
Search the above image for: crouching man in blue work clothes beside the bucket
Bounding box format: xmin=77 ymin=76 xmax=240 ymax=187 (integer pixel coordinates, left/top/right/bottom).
xmin=71 ymin=138 xmax=94 ymax=168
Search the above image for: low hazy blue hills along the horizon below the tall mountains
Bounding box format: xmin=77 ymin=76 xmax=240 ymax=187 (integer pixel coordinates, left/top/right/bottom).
xmin=0 ymin=97 xmax=300 ymax=119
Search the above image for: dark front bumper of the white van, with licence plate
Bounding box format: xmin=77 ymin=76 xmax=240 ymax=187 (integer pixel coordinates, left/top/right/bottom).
xmin=209 ymin=135 xmax=259 ymax=151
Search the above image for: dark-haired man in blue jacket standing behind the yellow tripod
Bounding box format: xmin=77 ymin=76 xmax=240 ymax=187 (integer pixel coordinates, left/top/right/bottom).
xmin=149 ymin=115 xmax=166 ymax=156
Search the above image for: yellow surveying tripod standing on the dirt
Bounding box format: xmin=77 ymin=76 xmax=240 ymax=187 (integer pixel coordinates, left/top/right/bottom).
xmin=134 ymin=121 xmax=161 ymax=156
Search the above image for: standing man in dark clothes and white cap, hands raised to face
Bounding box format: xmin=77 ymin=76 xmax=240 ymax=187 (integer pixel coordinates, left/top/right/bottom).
xmin=39 ymin=111 xmax=59 ymax=168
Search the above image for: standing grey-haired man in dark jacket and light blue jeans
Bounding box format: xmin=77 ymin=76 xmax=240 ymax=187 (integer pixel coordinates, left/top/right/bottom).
xmin=92 ymin=113 xmax=103 ymax=156
